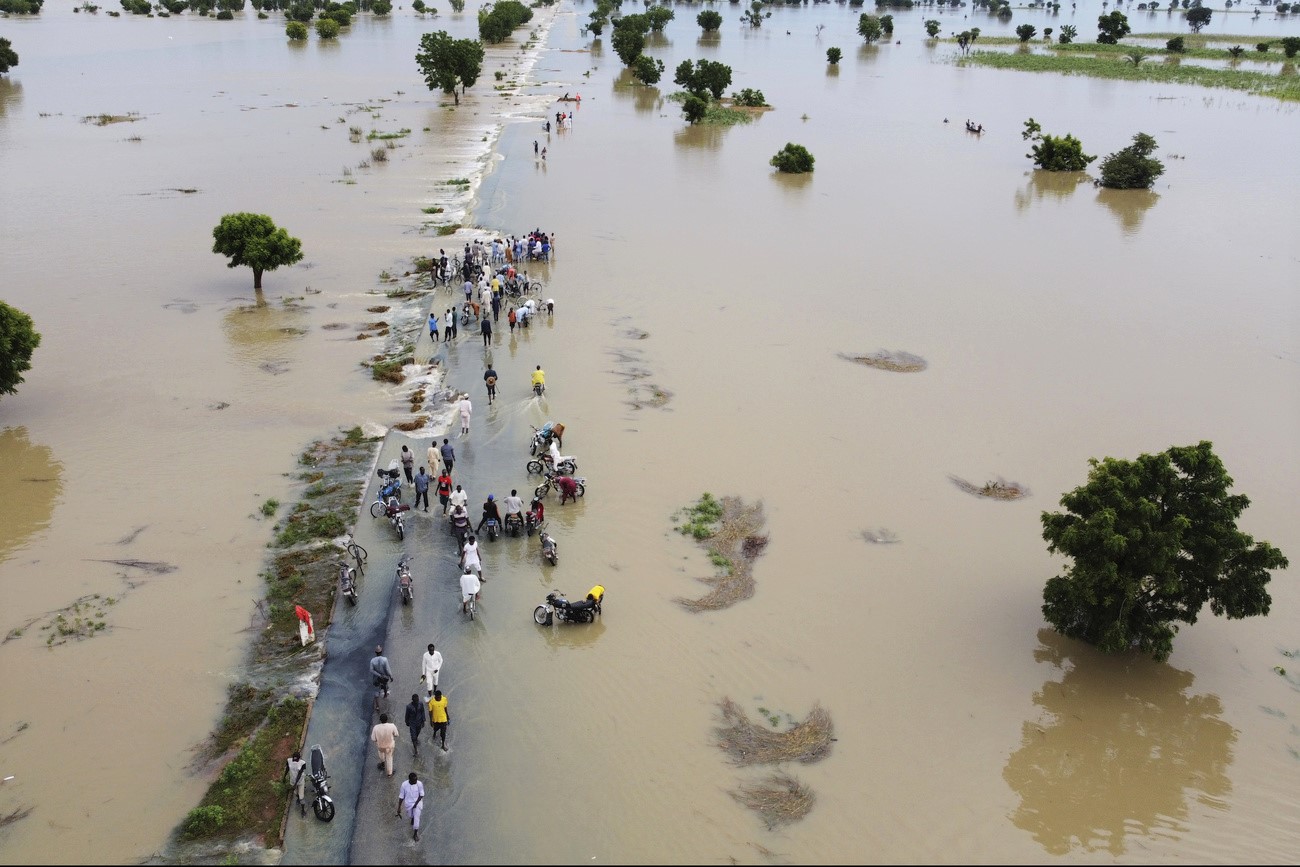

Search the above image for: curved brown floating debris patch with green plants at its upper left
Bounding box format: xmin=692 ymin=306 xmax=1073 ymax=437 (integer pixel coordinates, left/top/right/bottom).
xmin=673 ymin=493 xmax=767 ymax=612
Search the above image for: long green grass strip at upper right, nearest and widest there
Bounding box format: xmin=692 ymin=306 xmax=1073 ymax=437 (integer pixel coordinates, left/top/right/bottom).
xmin=957 ymin=51 xmax=1300 ymax=100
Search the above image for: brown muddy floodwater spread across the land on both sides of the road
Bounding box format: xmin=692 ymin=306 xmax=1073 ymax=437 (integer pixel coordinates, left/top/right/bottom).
xmin=0 ymin=3 xmax=1300 ymax=863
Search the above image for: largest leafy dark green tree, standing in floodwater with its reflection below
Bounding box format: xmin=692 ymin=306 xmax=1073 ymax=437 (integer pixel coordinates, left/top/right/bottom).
xmin=1043 ymin=442 xmax=1287 ymax=662
